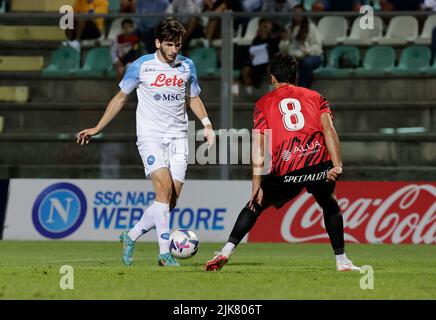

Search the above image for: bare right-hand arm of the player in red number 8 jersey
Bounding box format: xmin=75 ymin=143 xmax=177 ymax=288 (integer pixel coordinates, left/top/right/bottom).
xmin=321 ymin=112 xmax=343 ymax=182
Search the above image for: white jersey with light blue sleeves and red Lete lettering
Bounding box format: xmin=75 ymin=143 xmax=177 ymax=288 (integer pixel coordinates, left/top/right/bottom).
xmin=120 ymin=53 xmax=201 ymax=141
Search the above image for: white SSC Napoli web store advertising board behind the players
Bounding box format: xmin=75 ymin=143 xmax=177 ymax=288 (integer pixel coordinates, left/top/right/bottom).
xmin=4 ymin=179 xmax=251 ymax=242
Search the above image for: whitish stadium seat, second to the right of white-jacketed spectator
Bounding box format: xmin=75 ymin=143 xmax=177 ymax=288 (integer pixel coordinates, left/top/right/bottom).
xmin=338 ymin=16 xmax=383 ymax=45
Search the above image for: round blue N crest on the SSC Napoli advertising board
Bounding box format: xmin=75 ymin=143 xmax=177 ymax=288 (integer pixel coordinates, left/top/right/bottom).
xmin=32 ymin=183 xmax=87 ymax=239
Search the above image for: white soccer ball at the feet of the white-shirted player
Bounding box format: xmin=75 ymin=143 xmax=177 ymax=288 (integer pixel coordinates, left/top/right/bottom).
xmin=170 ymin=230 xmax=200 ymax=259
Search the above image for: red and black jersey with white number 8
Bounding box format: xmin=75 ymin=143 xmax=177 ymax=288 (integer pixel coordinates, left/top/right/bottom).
xmin=254 ymin=85 xmax=333 ymax=176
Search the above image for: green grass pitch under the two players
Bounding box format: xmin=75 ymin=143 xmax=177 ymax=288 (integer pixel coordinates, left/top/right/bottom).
xmin=0 ymin=241 xmax=436 ymax=299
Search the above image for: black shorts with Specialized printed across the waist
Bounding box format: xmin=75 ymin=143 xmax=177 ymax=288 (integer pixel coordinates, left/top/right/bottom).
xmin=259 ymin=161 xmax=336 ymax=210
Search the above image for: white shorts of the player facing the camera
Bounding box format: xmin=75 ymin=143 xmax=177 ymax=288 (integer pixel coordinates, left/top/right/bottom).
xmin=137 ymin=138 xmax=188 ymax=183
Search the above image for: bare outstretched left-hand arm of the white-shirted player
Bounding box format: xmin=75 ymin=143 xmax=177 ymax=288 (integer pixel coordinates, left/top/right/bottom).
xmin=77 ymin=90 xmax=129 ymax=146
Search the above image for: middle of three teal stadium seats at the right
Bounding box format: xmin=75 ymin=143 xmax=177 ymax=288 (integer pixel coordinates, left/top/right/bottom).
xmin=354 ymin=46 xmax=395 ymax=76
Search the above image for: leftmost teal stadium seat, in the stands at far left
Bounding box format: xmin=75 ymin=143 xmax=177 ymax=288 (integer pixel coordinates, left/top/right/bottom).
xmin=42 ymin=47 xmax=80 ymax=76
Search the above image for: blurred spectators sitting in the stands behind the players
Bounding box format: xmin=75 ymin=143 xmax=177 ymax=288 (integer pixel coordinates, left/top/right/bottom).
xmin=0 ymin=0 xmax=436 ymax=89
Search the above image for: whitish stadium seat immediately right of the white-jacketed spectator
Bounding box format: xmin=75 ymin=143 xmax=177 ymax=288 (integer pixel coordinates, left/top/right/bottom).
xmin=318 ymin=16 xmax=348 ymax=45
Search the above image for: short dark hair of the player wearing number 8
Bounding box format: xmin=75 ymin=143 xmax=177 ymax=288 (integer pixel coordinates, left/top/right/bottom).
xmin=270 ymin=53 xmax=298 ymax=84
